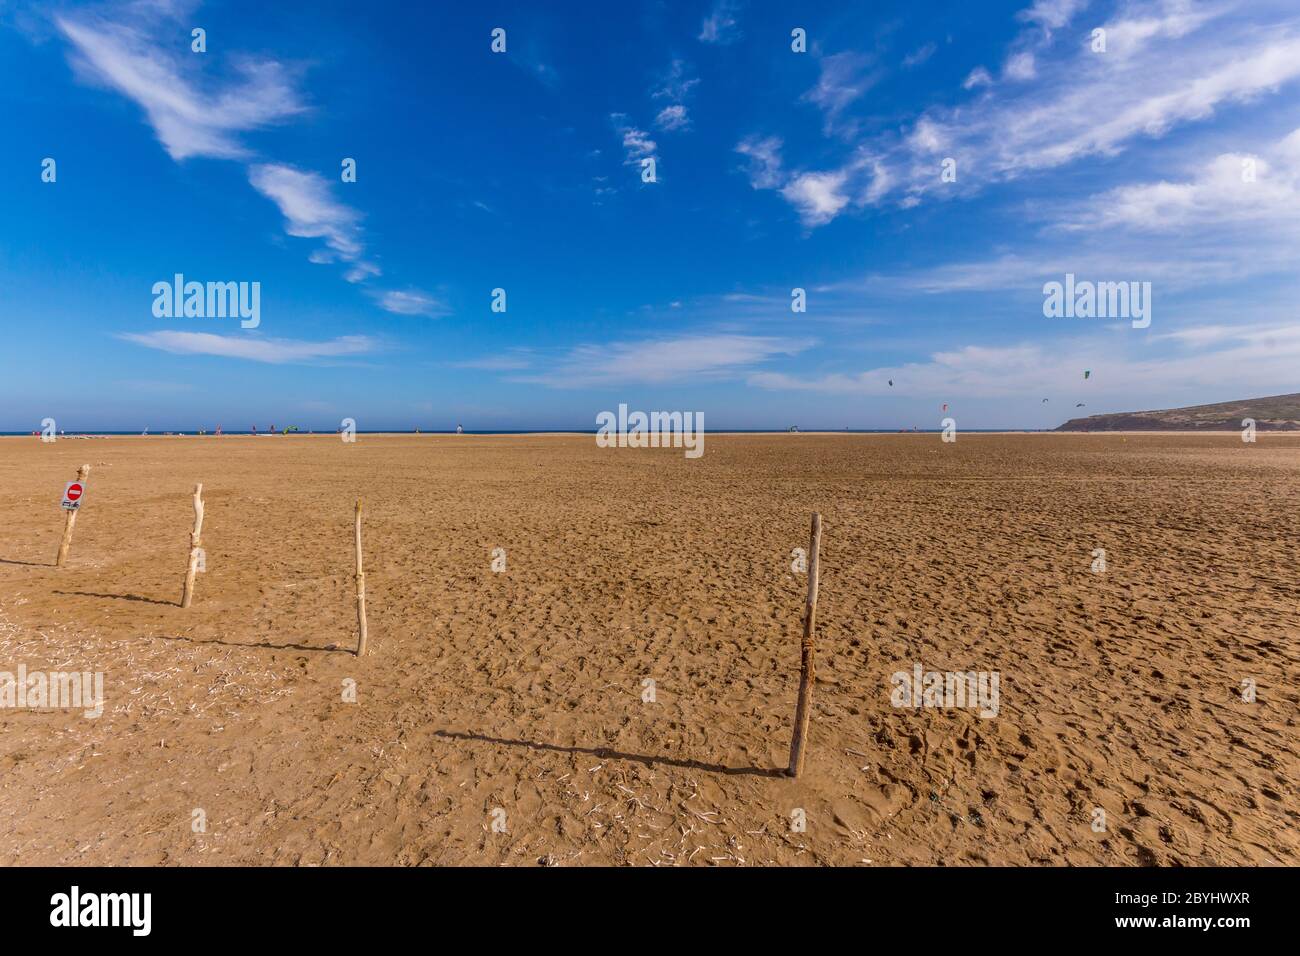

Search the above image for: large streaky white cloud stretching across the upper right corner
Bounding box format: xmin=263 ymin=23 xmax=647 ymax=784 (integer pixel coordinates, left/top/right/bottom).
xmin=748 ymin=0 xmax=1300 ymax=225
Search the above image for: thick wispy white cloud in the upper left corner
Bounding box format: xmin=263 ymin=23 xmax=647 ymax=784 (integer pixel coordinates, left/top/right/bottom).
xmin=55 ymin=7 xmax=304 ymax=160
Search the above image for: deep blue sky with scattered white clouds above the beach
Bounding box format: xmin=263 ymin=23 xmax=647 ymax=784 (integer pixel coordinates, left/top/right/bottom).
xmin=0 ymin=0 xmax=1300 ymax=431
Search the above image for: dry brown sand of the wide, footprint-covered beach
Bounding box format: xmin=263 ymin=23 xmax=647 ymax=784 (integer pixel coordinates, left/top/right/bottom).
xmin=0 ymin=434 xmax=1300 ymax=866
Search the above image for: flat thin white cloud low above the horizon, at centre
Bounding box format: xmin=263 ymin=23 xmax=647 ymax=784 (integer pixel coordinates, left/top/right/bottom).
xmin=520 ymin=333 xmax=813 ymax=388
